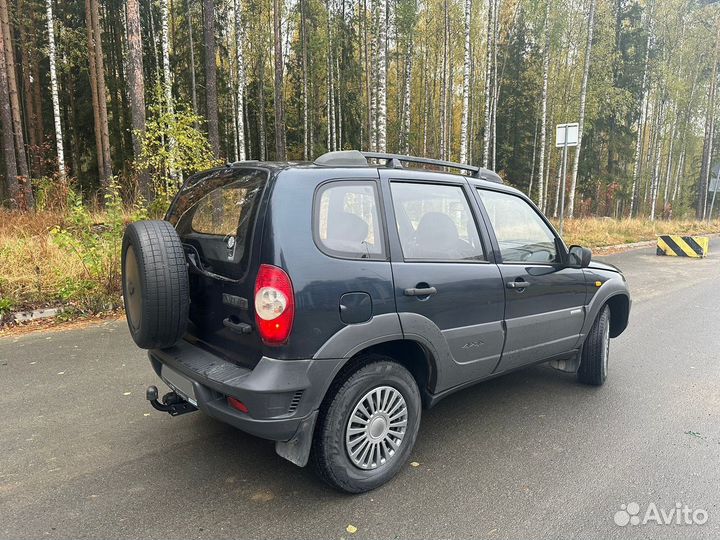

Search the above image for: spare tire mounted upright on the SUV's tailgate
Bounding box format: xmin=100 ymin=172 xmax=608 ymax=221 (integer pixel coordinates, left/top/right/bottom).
xmin=122 ymin=221 xmax=190 ymax=349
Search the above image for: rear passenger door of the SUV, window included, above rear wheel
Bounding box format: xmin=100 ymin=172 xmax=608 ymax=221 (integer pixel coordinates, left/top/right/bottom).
xmin=380 ymin=169 xmax=504 ymax=392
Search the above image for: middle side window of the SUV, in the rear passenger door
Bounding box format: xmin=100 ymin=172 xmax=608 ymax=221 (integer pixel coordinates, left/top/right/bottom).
xmin=391 ymin=182 xmax=484 ymax=261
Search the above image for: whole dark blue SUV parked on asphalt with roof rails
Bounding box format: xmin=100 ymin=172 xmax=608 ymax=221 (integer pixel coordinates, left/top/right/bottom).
xmin=122 ymin=151 xmax=630 ymax=493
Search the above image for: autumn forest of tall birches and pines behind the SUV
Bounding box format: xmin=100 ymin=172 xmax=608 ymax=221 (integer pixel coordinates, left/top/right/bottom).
xmin=0 ymin=0 xmax=720 ymax=220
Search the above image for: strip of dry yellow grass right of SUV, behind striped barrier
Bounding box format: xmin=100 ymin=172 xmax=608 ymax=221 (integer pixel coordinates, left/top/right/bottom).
xmin=563 ymin=218 xmax=720 ymax=248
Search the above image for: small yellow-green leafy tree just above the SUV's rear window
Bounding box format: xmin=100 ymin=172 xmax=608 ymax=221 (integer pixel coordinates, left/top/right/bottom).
xmin=138 ymin=84 xmax=219 ymax=214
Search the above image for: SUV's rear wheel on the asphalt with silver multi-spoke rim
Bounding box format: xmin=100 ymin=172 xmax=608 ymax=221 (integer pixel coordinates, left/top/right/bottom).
xmin=310 ymin=355 xmax=422 ymax=493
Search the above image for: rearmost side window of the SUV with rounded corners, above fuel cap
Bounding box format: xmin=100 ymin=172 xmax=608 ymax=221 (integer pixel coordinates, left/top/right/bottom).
xmin=313 ymin=180 xmax=385 ymax=259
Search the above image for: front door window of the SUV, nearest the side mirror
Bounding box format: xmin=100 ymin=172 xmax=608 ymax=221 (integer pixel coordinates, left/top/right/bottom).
xmin=478 ymin=189 xmax=559 ymax=263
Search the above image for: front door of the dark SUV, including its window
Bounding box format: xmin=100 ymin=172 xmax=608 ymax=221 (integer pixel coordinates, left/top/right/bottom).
xmin=477 ymin=188 xmax=586 ymax=371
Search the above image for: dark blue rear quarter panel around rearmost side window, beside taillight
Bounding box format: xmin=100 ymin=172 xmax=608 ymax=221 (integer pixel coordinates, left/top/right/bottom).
xmin=261 ymin=168 xmax=400 ymax=359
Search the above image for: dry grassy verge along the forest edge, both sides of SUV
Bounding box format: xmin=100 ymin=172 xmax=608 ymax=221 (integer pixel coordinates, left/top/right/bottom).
xmin=0 ymin=213 xmax=720 ymax=325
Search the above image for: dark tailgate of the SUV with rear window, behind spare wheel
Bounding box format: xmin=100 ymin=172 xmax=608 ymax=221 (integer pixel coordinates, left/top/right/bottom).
xmin=167 ymin=167 xmax=268 ymax=367
